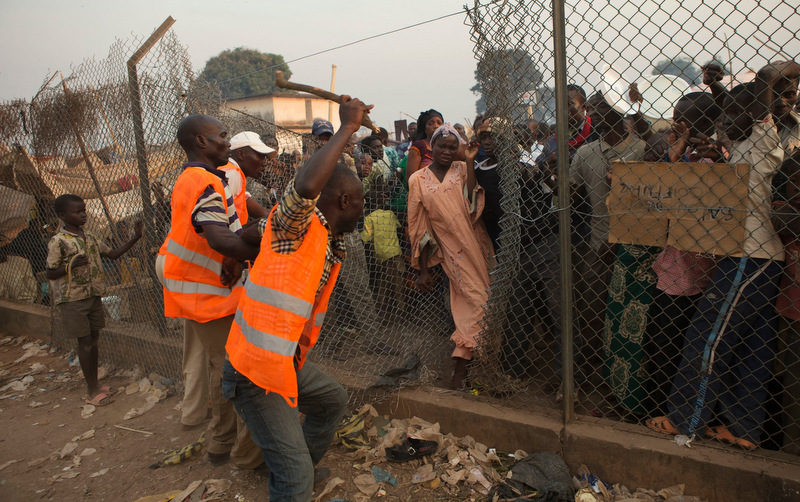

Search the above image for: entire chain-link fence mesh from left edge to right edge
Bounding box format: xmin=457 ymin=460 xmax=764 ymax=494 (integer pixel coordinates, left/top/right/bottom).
xmin=0 ymin=0 xmax=800 ymax=462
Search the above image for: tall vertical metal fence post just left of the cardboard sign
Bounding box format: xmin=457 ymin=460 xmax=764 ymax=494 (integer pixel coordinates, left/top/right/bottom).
xmin=553 ymin=0 xmax=575 ymax=424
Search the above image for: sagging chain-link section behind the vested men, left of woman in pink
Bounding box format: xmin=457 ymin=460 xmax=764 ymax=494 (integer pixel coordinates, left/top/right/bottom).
xmin=220 ymin=109 xmax=452 ymax=401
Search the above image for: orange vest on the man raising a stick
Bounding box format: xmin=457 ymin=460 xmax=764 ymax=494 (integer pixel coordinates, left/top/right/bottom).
xmin=225 ymin=208 xmax=341 ymax=407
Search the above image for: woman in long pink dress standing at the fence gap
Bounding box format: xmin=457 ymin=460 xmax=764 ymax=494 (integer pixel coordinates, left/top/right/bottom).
xmin=408 ymin=124 xmax=493 ymax=388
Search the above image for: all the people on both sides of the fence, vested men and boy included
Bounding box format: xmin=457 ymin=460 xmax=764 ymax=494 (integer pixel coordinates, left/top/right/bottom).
xmin=3 ymin=46 xmax=800 ymax=500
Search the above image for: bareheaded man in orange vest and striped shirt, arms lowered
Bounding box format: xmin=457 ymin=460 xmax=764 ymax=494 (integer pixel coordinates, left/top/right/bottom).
xmin=159 ymin=115 xmax=258 ymax=467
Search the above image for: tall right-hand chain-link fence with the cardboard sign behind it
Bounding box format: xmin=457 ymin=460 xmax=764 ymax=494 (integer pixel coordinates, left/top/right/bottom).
xmin=469 ymin=0 xmax=800 ymax=453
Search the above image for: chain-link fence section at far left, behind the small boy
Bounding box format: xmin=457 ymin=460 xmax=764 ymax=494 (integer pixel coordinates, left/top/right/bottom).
xmin=0 ymin=32 xmax=193 ymax=374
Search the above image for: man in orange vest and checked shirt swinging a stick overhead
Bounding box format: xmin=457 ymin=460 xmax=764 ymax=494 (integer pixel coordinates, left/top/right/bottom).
xmin=222 ymin=96 xmax=372 ymax=502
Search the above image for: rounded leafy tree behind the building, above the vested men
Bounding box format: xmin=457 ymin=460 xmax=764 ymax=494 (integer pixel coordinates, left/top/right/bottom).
xmin=199 ymin=47 xmax=292 ymax=99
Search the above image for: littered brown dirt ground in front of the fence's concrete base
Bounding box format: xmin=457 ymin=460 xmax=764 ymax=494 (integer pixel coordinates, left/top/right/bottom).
xmin=0 ymin=331 xmax=712 ymax=502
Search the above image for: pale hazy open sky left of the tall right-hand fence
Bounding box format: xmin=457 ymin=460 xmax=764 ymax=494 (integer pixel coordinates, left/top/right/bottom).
xmin=0 ymin=0 xmax=476 ymax=131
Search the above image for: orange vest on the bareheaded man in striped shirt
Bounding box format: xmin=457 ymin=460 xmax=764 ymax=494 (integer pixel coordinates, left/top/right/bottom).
xmin=159 ymin=166 xmax=241 ymax=322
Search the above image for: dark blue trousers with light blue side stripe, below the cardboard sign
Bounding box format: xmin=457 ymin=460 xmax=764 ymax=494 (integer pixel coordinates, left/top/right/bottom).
xmin=667 ymin=257 xmax=783 ymax=444
